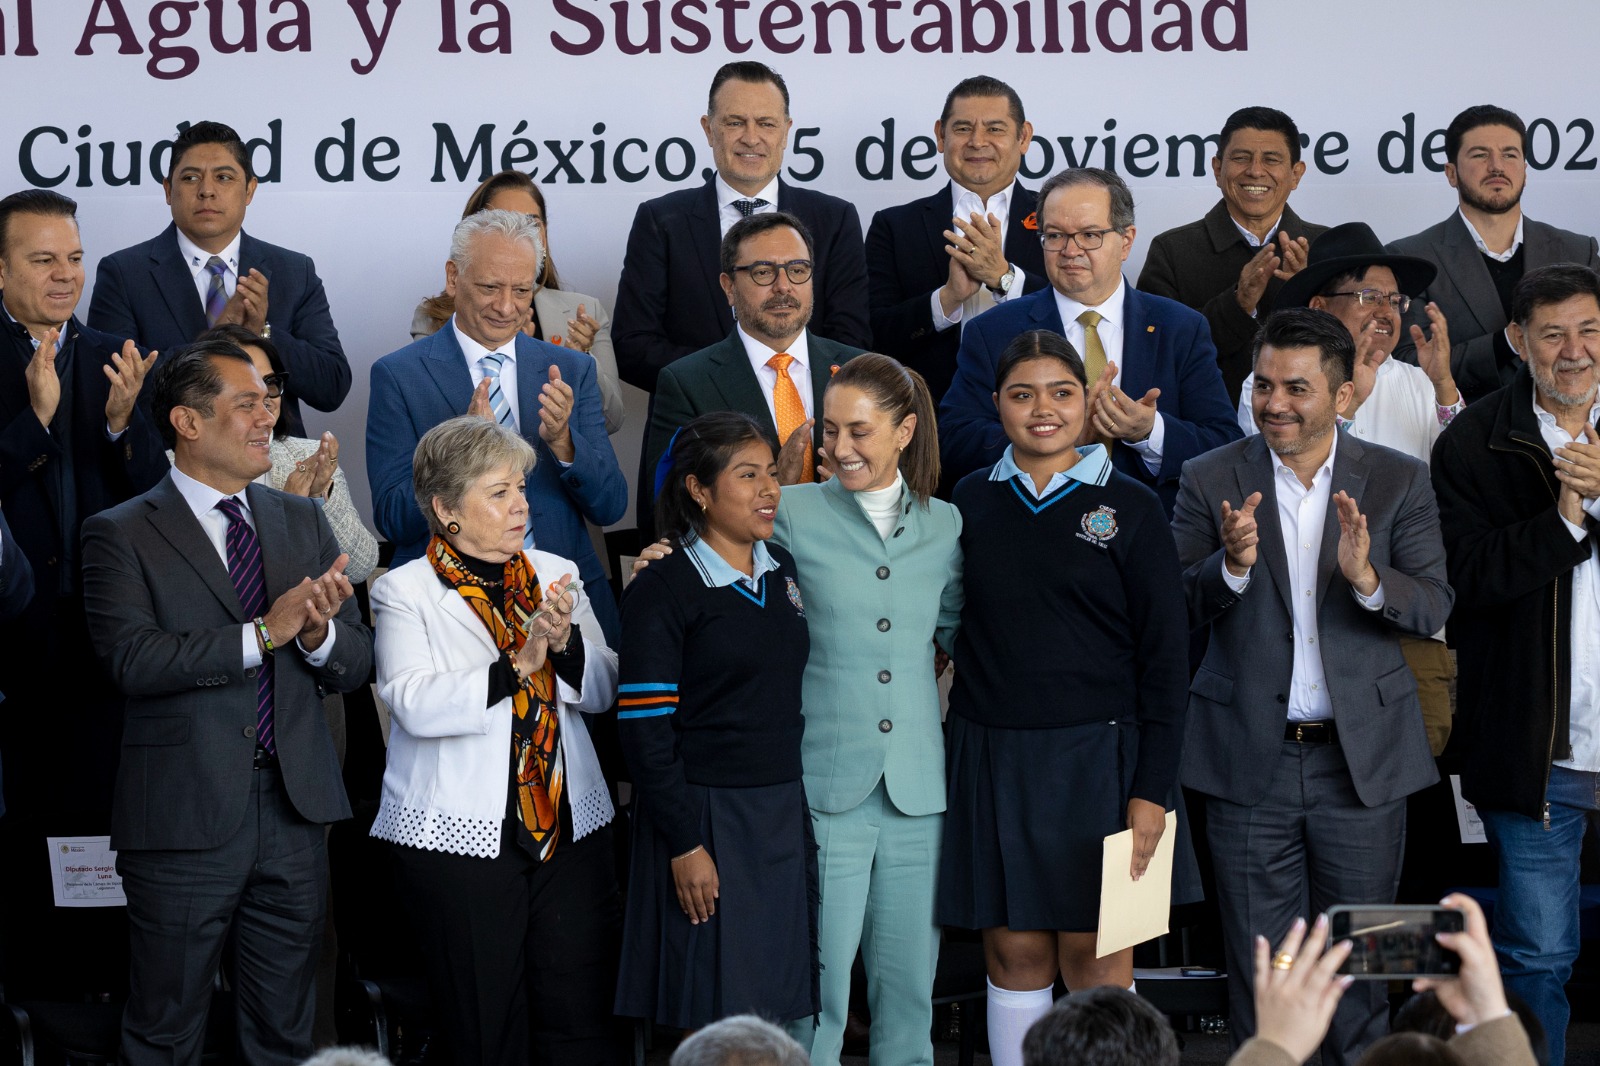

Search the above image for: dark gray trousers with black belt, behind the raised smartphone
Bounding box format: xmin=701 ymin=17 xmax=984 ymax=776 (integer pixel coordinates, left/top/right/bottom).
xmin=1206 ymin=741 xmax=1405 ymax=1066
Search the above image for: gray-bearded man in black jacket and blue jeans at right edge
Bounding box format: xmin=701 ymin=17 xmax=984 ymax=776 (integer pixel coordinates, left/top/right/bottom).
xmin=1434 ymin=262 xmax=1600 ymax=1066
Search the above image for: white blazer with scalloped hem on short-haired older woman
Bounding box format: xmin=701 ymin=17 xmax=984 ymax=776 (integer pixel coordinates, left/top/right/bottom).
xmin=373 ymin=551 xmax=616 ymax=858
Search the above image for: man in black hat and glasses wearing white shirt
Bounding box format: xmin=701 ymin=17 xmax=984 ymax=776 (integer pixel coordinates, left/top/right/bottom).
xmin=1238 ymin=222 xmax=1466 ymax=757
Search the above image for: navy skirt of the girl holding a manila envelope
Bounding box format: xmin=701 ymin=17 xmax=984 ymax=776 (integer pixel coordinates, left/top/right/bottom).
xmin=936 ymin=714 xmax=1202 ymax=933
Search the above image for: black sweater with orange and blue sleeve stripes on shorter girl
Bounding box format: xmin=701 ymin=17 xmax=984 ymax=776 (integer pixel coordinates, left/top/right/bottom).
xmin=618 ymin=544 xmax=811 ymax=855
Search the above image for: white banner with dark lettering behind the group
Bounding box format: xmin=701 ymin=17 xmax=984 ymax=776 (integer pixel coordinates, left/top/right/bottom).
xmin=0 ymin=0 xmax=1600 ymax=523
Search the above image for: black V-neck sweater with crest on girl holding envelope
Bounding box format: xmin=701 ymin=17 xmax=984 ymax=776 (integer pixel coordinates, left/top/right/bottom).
xmin=950 ymin=471 xmax=1189 ymax=805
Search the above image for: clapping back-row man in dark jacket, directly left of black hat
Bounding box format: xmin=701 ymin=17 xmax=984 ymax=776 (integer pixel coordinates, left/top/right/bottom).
xmin=1139 ymin=107 xmax=1324 ymax=397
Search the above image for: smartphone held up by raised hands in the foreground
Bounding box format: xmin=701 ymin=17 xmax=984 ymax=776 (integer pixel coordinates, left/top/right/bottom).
xmin=1328 ymin=903 xmax=1467 ymax=980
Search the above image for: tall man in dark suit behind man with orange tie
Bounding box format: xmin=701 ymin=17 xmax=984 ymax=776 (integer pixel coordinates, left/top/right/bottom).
xmin=611 ymin=61 xmax=870 ymax=392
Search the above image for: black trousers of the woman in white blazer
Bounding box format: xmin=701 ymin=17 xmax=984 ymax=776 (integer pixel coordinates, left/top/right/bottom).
xmin=394 ymin=821 xmax=622 ymax=1066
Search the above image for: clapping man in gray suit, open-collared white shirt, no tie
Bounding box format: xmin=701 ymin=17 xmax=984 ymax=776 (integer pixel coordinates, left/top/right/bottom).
xmin=1173 ymin=307 xmax=1453 ymax=1066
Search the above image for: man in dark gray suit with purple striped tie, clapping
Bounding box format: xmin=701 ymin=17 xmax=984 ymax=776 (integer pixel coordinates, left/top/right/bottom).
xmin=83 ymin=341 xmax=371 ymax=1066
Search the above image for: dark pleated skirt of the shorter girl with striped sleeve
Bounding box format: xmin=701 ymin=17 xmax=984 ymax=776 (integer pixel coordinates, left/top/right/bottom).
xmin=616 ymin=781 xmax=821 ymax=1029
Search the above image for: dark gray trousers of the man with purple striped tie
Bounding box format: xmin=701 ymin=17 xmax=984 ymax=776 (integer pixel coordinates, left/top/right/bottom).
xmin=117 ymin=770 xmax=328 ymax=1066
